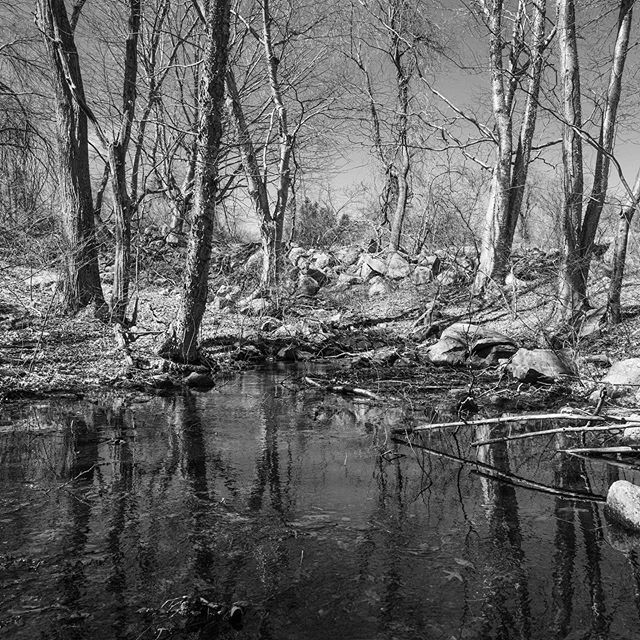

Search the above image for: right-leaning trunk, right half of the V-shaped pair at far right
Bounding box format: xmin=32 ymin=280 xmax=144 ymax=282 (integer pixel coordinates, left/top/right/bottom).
xmin=580 ymin=0 xmax=635 ymax=291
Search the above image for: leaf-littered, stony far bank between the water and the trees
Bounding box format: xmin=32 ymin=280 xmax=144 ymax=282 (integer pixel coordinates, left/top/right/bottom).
xmin=0 ymin=242 xmax=640 ymax=412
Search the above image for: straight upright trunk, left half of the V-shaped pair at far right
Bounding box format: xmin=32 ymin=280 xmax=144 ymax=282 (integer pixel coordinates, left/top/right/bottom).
xmin=558 ymin=0 xmax=586 ymax=322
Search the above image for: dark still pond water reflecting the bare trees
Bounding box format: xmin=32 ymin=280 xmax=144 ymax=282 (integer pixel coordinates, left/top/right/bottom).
xmin=0 ymin=371 xmax=640 ymax=640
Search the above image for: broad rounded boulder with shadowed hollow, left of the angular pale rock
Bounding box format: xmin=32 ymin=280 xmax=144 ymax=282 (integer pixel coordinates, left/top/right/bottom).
xmin=436 ymin=322 xmax=518 ymax=365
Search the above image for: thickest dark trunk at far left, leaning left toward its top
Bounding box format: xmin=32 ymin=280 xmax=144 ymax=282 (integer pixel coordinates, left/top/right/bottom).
xmin=36 ymin=0 xmax=104 ymax=311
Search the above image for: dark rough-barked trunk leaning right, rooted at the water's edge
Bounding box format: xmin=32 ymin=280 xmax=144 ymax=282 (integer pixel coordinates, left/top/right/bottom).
xmin=160 ymin=0 xmax=231 ymax=362
